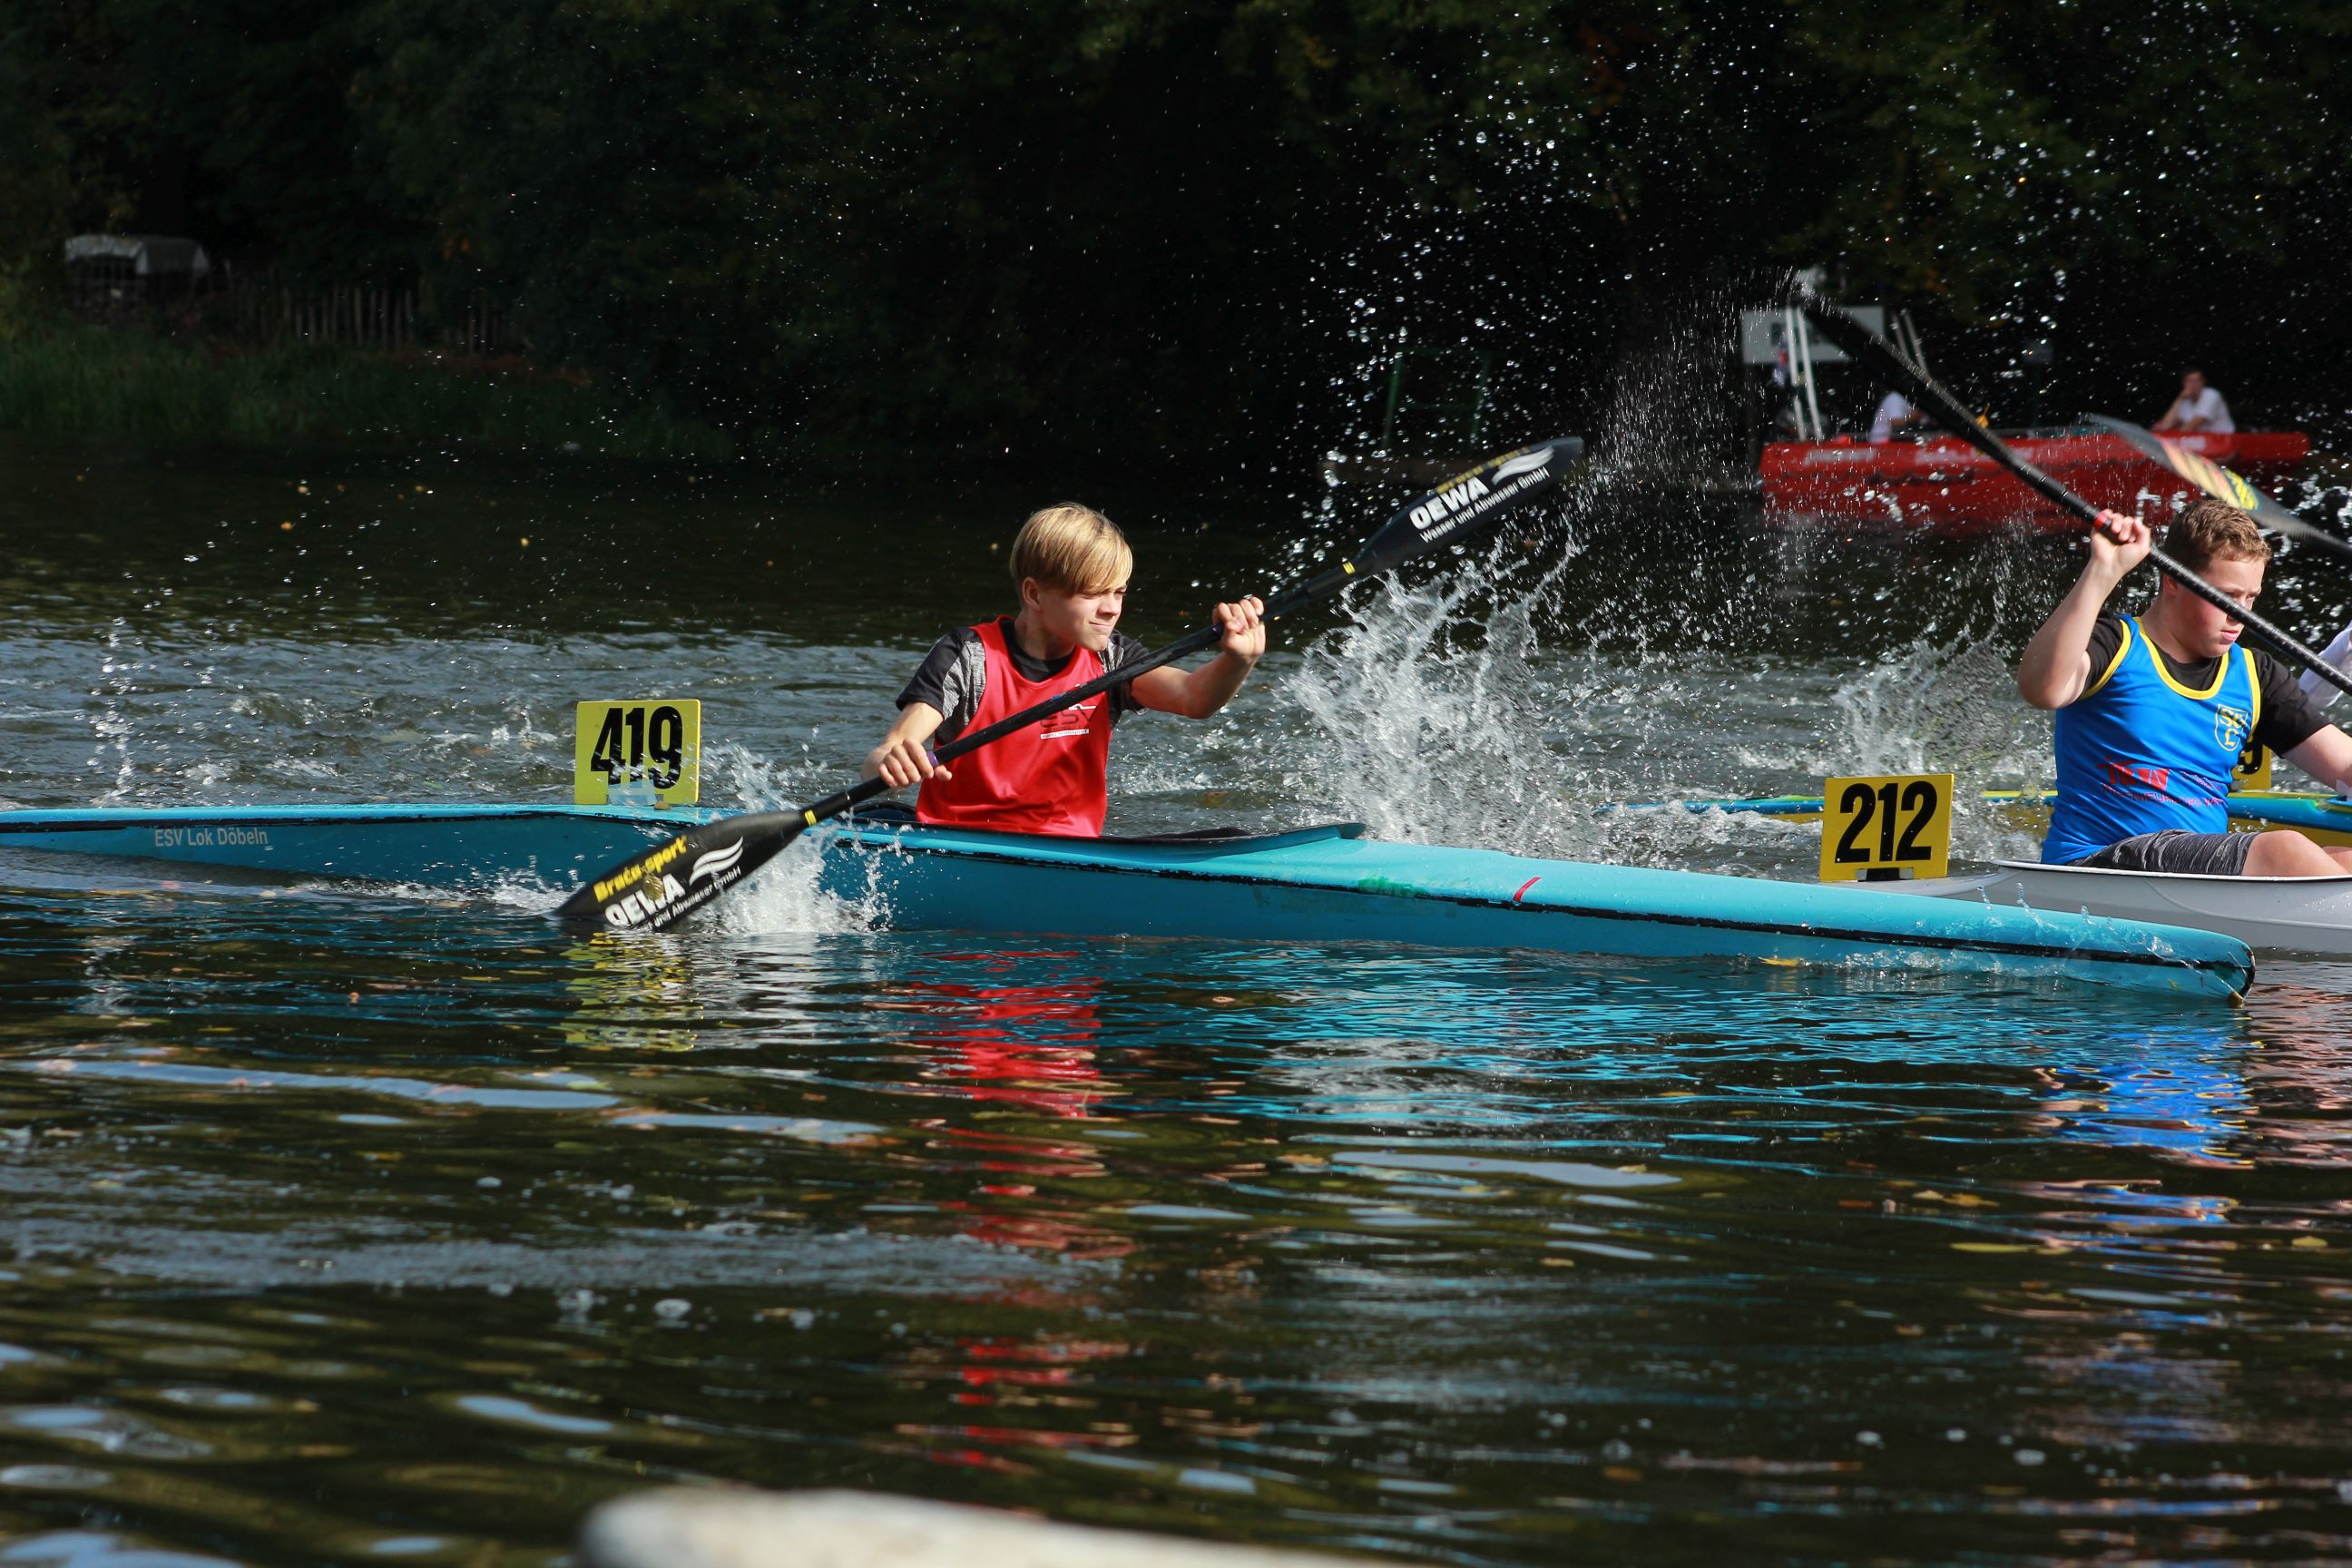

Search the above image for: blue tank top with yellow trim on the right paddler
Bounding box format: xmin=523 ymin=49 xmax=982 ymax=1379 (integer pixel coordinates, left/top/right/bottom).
xmin=2042 ymin=618 xmax=2263 ymax=865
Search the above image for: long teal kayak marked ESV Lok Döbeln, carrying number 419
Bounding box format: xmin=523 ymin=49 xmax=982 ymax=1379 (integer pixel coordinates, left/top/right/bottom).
xmin=0 ymin=804 xmax=2253 ymax=996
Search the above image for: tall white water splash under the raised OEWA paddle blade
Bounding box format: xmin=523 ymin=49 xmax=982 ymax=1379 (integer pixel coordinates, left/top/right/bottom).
xmin=1282 ymin=287 xmax=1748 ymax=860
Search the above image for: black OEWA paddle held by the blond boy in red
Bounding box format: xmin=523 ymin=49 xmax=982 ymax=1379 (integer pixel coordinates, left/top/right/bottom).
xmin=557 ymin=435 xmax=1583 ymax=931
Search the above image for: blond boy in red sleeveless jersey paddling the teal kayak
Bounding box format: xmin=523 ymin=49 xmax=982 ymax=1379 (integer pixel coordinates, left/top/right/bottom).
xmin=866 ymin=501 xmax=1265 ymax=837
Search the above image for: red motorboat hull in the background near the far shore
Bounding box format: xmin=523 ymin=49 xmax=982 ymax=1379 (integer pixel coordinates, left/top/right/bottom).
xmin=1761 ymin=428 xmax=2312 ymax=529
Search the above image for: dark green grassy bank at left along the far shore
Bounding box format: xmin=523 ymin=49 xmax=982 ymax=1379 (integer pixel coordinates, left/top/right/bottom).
xmin=0 ymin=322 xmax=734 ymax=461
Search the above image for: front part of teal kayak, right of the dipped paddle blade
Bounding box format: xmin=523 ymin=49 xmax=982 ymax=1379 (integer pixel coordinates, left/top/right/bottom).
xmin=823 ymin=825 xmax=2253 ymax=996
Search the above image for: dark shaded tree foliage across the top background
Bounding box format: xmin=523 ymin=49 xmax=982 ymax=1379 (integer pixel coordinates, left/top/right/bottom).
xmin=0 ymin=0 xmax=2352 ymax=461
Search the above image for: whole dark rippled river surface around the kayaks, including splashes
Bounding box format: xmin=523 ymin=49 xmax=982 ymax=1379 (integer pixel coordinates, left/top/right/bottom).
xmin=0 ymin=435 xmax=2352 ymax=1568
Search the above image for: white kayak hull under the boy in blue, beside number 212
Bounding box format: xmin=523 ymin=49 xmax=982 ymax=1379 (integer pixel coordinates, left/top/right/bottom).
xmin=1872 ymin=860 xmax=2352 ymax=959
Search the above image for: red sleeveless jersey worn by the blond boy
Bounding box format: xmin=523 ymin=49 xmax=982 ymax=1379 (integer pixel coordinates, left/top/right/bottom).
xmin=915 ymin=621 xmax=1110 ymax=839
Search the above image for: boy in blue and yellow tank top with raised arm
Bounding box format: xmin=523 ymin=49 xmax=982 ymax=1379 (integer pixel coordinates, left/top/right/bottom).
xmin=2018 ymin=501 xmax=2352 ymax=877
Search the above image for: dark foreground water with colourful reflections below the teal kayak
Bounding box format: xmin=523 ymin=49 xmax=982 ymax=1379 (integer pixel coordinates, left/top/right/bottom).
xmin=0 ymin=891 xmax=2352 ymax=1563
